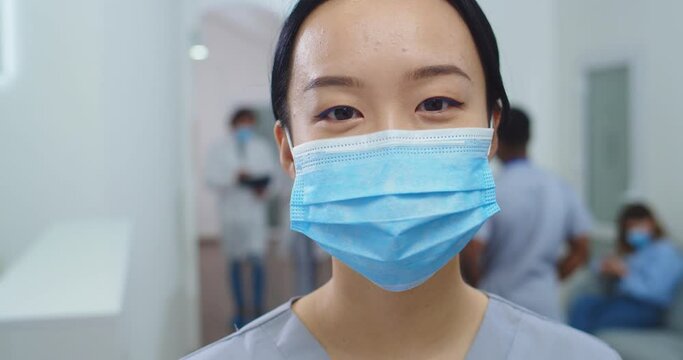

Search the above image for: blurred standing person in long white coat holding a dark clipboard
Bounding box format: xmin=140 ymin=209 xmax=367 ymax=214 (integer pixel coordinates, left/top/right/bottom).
xmin=205 ymin=108 xmax=276 ymax=328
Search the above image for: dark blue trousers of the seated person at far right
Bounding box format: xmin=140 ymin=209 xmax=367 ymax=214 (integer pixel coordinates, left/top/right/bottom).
xmin=569 ymin=295 xmax=664 ymax=334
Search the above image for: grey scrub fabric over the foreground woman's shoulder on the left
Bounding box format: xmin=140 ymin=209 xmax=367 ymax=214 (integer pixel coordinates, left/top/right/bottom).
xmin=183 ymin=301 xmax=292 ymax=360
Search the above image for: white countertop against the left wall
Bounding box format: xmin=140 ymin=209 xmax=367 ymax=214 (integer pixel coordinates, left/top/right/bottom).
xmin=0 ymin=220 xmax=132 ymax=324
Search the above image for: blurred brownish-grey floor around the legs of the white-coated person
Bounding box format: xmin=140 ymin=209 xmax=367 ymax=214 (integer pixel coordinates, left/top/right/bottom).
xmin=199 ymin=239 xmax=330 ymax=345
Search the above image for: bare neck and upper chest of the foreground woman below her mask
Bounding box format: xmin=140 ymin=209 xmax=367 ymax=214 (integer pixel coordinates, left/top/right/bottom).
xmin=294 ymin=257 xmax=488 ymax=359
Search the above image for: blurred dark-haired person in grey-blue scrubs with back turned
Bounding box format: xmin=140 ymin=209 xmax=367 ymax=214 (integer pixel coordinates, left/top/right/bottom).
xmin=463 ymin=108 xmax=591 ymax=320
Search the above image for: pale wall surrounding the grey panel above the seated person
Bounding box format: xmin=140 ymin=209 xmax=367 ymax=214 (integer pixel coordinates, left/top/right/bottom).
xmin=556 ymin=0 xmax=683 ymax=241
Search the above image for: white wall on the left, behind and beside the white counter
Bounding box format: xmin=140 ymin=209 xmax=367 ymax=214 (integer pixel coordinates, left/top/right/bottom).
xmin=0 ymin=0 xmax=194 ymax=359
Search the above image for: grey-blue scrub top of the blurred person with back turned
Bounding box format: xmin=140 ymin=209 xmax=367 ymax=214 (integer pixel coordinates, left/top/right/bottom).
xmin=476 ymin=160 xmax=591 ymax=320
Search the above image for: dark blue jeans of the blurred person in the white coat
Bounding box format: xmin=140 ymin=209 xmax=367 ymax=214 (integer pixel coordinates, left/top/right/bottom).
xmin=228 ymin=257 xmax=264 ymax=328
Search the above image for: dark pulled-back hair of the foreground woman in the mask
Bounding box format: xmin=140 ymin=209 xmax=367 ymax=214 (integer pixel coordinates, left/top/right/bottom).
xmin=270 ymin=0 xmax=510 ymax=126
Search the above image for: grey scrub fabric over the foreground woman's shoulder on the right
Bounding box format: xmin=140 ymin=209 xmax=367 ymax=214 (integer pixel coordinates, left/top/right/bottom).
xmin=480 ymin=295 xmax=621 ymax=360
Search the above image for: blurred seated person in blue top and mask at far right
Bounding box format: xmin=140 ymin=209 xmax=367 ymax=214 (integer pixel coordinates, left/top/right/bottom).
xmin=569 ymin=204 xmax=683 ymax=333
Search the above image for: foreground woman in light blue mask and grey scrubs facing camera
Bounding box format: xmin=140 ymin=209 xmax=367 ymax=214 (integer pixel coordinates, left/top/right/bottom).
xmin=182 ymin=0 xmax=619 ymax=360
